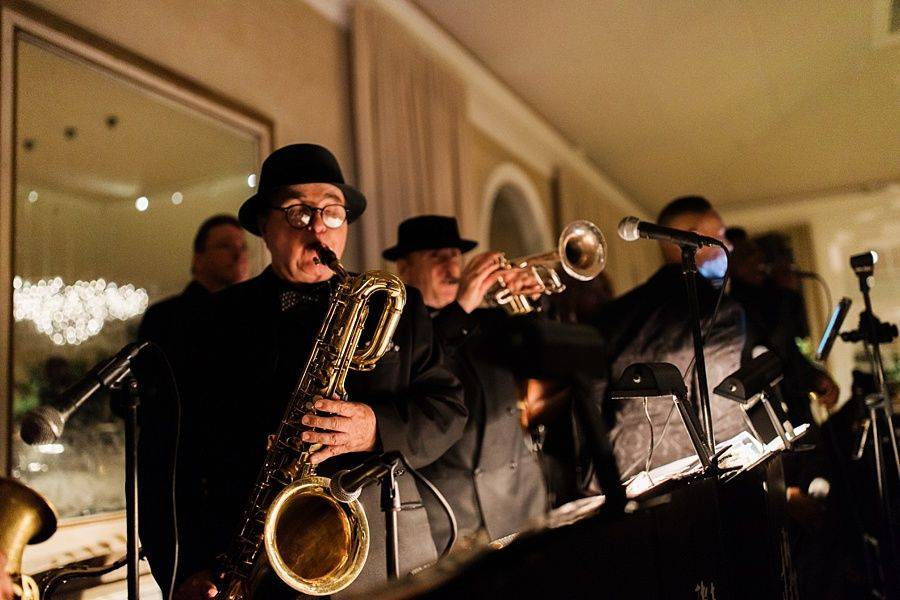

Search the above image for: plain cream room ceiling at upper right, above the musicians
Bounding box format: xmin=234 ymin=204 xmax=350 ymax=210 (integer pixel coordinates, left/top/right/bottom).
xmin=415 ymin=0 xmax=900 ymax=213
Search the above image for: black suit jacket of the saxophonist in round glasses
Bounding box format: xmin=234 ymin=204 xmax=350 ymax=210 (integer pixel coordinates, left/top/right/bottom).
xmin=166 ymin=269 xmax=466 ymax=591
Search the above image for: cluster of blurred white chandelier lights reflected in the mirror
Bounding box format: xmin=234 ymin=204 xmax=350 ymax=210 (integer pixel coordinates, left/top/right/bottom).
xmin=13 ymin=276 xmax=149 ymax=346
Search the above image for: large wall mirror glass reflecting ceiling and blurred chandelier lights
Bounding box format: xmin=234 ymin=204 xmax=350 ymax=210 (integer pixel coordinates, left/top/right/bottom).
xmin=3 ymin=11 xmax=269 ymax=518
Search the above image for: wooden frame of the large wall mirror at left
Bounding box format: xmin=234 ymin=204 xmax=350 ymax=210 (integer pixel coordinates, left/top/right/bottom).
xmin=0 ymin=0 xmax=274 ymax=476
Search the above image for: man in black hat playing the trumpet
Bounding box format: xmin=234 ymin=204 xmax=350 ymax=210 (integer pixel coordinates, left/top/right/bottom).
xmin=383 ymin=215 xmax=547 ymax=548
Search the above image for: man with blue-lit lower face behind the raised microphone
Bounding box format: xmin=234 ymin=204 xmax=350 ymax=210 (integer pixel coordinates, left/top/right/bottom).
xmin=597 ymin=196 xmax=746 ymax=477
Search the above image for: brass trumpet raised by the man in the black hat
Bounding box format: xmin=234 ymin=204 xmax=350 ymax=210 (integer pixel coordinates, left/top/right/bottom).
xmin=487 ymin=220 xmax=607 ymax=315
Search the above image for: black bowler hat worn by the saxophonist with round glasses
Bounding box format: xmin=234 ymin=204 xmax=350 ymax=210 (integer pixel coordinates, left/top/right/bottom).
xmin=238 ymin=144 xmax=366 ymax=235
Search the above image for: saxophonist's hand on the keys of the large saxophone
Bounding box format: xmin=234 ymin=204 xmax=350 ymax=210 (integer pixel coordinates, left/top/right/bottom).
xmin=303 ymin=396 xmax=377 ymax=465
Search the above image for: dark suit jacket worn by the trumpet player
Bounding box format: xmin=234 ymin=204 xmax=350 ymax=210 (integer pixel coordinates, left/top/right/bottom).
xmin=423 ymin=302 xmax=547 ymax=548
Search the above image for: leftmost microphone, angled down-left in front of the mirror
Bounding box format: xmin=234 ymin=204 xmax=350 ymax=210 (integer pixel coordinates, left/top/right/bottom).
xmin=19 ymin=342 xmax=149 ymax=446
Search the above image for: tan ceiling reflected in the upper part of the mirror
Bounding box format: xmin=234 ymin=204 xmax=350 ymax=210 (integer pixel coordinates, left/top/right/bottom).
xmin=16 ymin=42 xmax=257 ymax=203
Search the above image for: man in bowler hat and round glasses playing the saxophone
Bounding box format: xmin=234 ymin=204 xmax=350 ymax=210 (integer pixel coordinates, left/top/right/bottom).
xmin=149 ymin=144 xmax=466 ymax=598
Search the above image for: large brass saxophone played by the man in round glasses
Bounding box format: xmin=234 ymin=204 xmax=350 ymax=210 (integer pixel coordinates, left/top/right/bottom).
xmin=214 ymin=245 xmax=406 ymax=600
